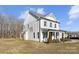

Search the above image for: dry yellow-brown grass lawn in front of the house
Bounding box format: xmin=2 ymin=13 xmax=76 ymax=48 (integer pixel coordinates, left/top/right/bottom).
xmin=0 ymin=39 xmax=79 ymax=54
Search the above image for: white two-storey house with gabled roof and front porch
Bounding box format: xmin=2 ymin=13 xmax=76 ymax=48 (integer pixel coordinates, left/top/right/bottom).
xmin=23 ymin=11 xmax=66 ymax=42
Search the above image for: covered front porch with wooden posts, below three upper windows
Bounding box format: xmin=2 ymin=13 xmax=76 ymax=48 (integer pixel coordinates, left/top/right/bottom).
xmin=41 ymin=30 xmax=61 ymax=43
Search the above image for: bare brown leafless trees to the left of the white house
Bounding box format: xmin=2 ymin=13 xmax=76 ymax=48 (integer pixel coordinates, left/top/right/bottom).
xmin=0 ymin=14 xmax=23 ymax=38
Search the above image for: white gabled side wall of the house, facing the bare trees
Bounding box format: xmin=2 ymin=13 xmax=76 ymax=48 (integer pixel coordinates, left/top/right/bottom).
xmin=24 ymin=13 xmax=39 ymax=41
